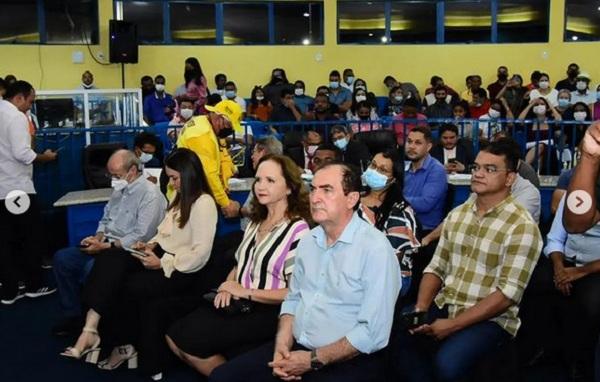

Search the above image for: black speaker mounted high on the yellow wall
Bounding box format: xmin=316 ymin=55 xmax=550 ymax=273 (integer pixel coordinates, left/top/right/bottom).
xmin=108 ymin=20 xmax=138 ymax=64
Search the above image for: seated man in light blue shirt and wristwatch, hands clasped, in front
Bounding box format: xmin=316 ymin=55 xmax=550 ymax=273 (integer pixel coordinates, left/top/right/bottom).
xmin=210 ymin=162 xmax=400 ymax=382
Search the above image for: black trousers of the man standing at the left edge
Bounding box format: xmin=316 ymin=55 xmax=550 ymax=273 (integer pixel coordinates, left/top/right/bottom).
xmin=0 ymin=194 xmax=47 ymax=297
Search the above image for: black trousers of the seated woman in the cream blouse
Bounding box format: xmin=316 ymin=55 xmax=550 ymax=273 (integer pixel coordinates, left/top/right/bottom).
xmin=83 ymin=249 xmax=196 ymax=347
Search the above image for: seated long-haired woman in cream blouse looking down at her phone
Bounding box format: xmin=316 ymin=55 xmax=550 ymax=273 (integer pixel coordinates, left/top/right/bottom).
xmin=62 ymin=148 xmax=217 ymax=370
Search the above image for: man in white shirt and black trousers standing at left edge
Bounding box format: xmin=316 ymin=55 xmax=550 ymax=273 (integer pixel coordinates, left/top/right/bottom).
xmin=0 ymin=81 xmax=56 ymax=305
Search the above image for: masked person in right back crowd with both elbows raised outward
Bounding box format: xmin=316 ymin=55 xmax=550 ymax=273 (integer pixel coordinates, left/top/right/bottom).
xmin=518 ymin=96 xmax=562 ymax=173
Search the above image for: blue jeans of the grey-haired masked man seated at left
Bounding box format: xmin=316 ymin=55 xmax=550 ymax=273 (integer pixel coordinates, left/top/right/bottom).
xmin=53 ymin=247 xmax=94 ymax=317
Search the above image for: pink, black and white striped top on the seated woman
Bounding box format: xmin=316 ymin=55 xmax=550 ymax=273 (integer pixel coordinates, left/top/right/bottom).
xmin=235 ymin=218 xmax=310 ymax=289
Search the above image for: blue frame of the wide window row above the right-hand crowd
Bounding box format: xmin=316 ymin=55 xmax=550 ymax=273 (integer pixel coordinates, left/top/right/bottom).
xmin=336 ymin=0 xmax=552 ymax=46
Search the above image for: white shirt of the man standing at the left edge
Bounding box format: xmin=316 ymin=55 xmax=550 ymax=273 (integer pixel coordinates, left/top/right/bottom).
xmin=0 ymin=101 xmax=37 ymax=200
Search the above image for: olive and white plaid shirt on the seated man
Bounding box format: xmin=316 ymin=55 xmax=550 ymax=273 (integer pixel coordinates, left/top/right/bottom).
xmin=424 ymin=195 xmax=542 ymax=336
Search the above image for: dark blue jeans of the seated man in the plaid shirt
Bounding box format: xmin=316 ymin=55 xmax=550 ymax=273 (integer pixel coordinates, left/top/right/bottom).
xmin=390 ymin=304 xmax=510 ymax=382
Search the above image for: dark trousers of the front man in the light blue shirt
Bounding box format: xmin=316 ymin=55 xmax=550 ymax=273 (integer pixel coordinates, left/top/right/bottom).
xmin=208 ymin=341 xmax=385 ymax=382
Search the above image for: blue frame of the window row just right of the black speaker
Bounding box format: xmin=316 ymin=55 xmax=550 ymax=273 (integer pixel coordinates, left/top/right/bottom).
xmin=116 ymin=0 xmax=325 ymax=47
